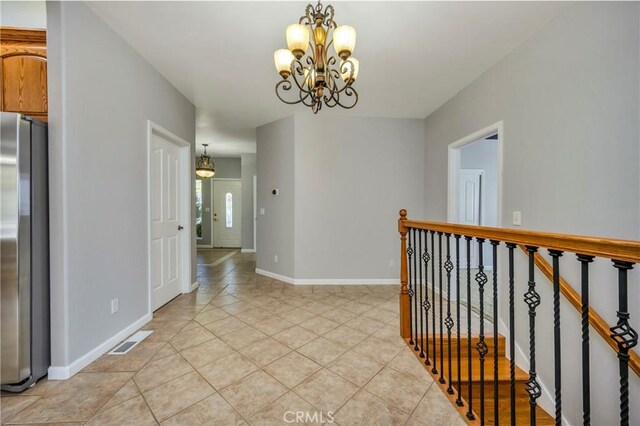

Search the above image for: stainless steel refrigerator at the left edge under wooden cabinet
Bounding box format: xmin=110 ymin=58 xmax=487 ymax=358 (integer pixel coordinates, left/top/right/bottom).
xmin=0 ymin=112 xmax=51 ymax=392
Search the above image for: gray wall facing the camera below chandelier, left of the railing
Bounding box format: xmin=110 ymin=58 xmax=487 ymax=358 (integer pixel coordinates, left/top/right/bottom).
xmin=294 ymin=114 xmax=424 ymax=280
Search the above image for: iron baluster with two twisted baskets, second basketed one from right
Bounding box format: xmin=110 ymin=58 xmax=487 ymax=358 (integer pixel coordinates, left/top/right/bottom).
xmin=524 ymin=246 xmax=541 ymax=426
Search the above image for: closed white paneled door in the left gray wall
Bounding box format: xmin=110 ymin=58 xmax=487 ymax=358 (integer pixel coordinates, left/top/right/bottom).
xmin=150 ymin=133 xmax=184 ymax=311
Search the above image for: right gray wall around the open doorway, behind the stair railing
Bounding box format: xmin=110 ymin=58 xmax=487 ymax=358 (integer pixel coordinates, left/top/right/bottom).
xmin=425 ymin=2 xmax=640 ymax=424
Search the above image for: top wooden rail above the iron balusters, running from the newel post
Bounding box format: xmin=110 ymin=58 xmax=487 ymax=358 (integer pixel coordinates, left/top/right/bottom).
xmin=400 ymin=220 xmax=640 ymax=263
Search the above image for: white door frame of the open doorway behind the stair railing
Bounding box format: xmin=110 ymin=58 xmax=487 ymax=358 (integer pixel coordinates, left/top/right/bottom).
xmin=447 ymin=121 xmax=504 ymax=228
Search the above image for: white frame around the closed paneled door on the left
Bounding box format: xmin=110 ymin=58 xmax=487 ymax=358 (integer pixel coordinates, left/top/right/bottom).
xmin=147 ymin=120 xmax=195 ymax=316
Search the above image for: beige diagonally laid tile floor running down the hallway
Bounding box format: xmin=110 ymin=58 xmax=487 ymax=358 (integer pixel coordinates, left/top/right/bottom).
xmin=0 ymin=250 xmax=465 ymax=426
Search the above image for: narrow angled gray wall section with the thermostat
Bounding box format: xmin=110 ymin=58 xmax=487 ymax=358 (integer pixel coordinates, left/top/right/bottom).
xmin=256 ymin=116 xmax=295 ymax=277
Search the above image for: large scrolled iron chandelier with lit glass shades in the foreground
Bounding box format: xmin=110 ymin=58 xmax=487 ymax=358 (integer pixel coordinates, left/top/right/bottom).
xmin=273 ymin=0 xmax=359 ymax=114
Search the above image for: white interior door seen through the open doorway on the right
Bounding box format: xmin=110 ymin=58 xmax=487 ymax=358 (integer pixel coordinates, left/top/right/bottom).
xmin=458 ymin=169 xmax=483 ymax=267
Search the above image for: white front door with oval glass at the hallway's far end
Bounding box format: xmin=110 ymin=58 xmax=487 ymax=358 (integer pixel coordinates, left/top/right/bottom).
xmin=213 ymin=180 xmax=242 ymax=247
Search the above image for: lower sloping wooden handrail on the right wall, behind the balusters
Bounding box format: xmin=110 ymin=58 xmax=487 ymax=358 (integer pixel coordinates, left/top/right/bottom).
xmin=519 ymin=244 xmax=640 ymax=376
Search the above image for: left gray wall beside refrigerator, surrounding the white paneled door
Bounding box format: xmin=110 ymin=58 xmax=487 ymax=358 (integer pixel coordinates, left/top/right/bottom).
xmin=47 ymin=2 xmax=196 ymax=367
